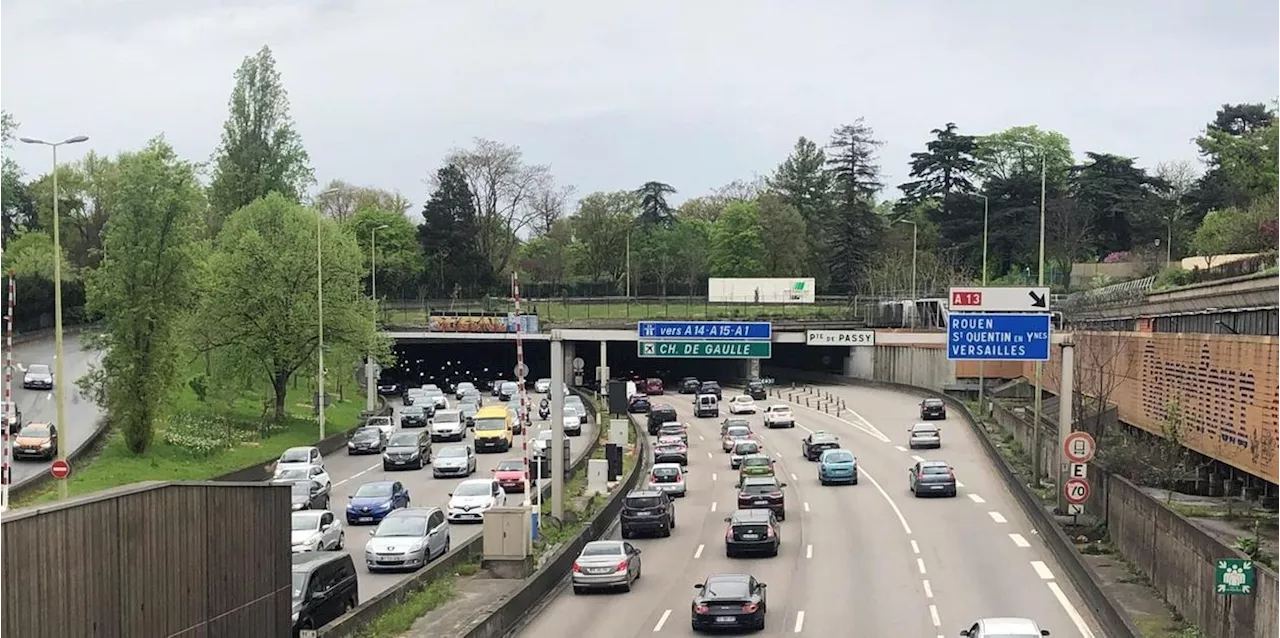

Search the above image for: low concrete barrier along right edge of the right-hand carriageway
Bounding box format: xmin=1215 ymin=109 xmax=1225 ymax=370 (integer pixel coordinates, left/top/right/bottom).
xmin=769 ymin=366 xmax=1142 ymax=638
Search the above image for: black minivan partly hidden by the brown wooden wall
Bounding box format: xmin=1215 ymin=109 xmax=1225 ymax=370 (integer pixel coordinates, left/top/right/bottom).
xmin=291 ymin=552 xmax=360 ymax=637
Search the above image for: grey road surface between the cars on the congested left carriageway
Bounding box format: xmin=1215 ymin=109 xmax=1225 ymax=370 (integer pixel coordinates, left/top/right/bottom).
xmin=317 ymin=395 xmax=596 ymax=602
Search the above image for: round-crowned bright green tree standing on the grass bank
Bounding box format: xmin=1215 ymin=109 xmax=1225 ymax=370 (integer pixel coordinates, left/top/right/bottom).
xmin=197 ymin=193 xmax=373 ymax=420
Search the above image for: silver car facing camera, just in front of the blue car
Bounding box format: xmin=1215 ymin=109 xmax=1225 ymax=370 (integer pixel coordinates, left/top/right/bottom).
xmin=365 ymin=507 xmax=449 ymax=571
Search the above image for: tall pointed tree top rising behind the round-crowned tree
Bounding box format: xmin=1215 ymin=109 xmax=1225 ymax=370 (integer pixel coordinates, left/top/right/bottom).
xmin=209 ymin=46 xmax=315 ymax=233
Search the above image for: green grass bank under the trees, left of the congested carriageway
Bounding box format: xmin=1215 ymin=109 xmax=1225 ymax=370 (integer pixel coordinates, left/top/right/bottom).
xmin=18 ymin=371 xmax=365 ymax=506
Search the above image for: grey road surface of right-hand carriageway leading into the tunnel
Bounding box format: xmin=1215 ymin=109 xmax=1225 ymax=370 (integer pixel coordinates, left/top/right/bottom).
xmin=521 ymin=387 xmax=1102 ymax=638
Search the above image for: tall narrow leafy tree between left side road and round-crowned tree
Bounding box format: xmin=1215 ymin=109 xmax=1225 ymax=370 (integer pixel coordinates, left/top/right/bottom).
xmin=87 ymin=138 xmax=204 ymax=454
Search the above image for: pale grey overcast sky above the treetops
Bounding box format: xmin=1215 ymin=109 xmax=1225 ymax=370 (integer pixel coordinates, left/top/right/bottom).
xmin=0 ymin=0 xmax=1280 ymax=210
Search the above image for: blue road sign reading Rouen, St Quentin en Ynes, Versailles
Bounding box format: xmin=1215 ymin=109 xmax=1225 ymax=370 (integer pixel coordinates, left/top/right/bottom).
xmin=947 ymin=313 xmax=1052 ymax=361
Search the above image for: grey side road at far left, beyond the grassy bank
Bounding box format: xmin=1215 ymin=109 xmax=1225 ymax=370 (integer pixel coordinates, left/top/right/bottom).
xmin=8 ymin=334 xmax=102 ymax=484
